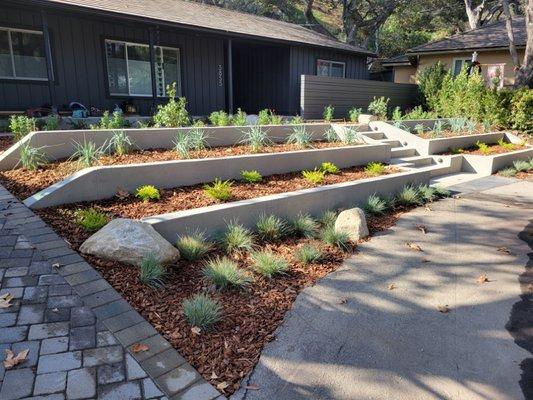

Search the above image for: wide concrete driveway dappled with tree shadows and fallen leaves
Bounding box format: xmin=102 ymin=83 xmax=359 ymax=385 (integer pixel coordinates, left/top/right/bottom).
xmin=234 ymin=177 xmax=533 ymax=400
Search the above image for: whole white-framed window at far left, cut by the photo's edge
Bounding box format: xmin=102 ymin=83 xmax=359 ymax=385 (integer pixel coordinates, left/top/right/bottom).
xmin=0 ymin=28 xmax=47 ymax=80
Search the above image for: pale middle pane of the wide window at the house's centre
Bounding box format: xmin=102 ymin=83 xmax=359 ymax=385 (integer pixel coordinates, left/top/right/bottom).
xmin=128 ymin=45 xmax=152 ymax=96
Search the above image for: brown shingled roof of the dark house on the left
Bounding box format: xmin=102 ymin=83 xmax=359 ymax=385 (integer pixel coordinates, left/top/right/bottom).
xmin=40 ymin=0 xmax=374 ymax=55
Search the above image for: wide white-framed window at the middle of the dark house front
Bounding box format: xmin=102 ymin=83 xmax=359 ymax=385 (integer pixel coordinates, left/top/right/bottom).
xmin=106 ymin=40 xmax=181 ymax=97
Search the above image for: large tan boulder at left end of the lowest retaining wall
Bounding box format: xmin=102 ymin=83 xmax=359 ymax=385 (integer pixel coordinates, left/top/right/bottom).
xmin=80 ymin=218 xmax=179 ymax=266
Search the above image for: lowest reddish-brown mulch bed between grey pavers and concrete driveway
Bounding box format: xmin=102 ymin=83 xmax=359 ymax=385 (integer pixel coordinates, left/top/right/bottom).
xmin=37 ymin=202 xmax=406 ymax=395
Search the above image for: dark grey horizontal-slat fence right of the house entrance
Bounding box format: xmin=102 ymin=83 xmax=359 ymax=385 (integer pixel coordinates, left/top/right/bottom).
xmin=300 ymin=75 xmax=418 ymax=119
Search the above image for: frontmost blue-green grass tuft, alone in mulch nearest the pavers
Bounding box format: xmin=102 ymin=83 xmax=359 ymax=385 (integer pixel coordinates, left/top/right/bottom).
xmin=183 ymin=294 xmax=222 ymax=330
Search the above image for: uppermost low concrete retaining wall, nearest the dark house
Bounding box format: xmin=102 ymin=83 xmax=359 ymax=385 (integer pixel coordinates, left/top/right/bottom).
xmin=0 ymin=124 xmax=338 ymax=171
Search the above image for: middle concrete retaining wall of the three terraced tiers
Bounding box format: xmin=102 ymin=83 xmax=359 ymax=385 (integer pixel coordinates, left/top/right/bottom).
xmin=24 ymin=144 xmax=391 ymax=209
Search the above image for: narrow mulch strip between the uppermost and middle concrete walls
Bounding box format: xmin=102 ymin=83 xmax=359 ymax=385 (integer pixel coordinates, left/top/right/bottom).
xmin=0 ymin=142 xmax=357 ymax=200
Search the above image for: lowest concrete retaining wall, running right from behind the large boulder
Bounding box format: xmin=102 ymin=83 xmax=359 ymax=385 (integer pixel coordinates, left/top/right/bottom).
xmin=143 ymin=168 xmax=431 ymax=243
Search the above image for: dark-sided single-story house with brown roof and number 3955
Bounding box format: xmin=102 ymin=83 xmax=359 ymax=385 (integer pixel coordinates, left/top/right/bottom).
xmin=0 ymin=0 xmax=373 ymax=115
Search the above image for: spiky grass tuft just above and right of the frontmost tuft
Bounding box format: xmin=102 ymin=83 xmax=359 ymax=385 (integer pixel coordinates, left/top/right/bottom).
xmin=202 ymin=257 xmax=252 ymax=290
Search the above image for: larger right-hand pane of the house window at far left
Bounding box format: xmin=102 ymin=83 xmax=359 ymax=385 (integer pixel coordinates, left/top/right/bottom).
xmin=11 ymin=31 xmax=47 ymax=79
